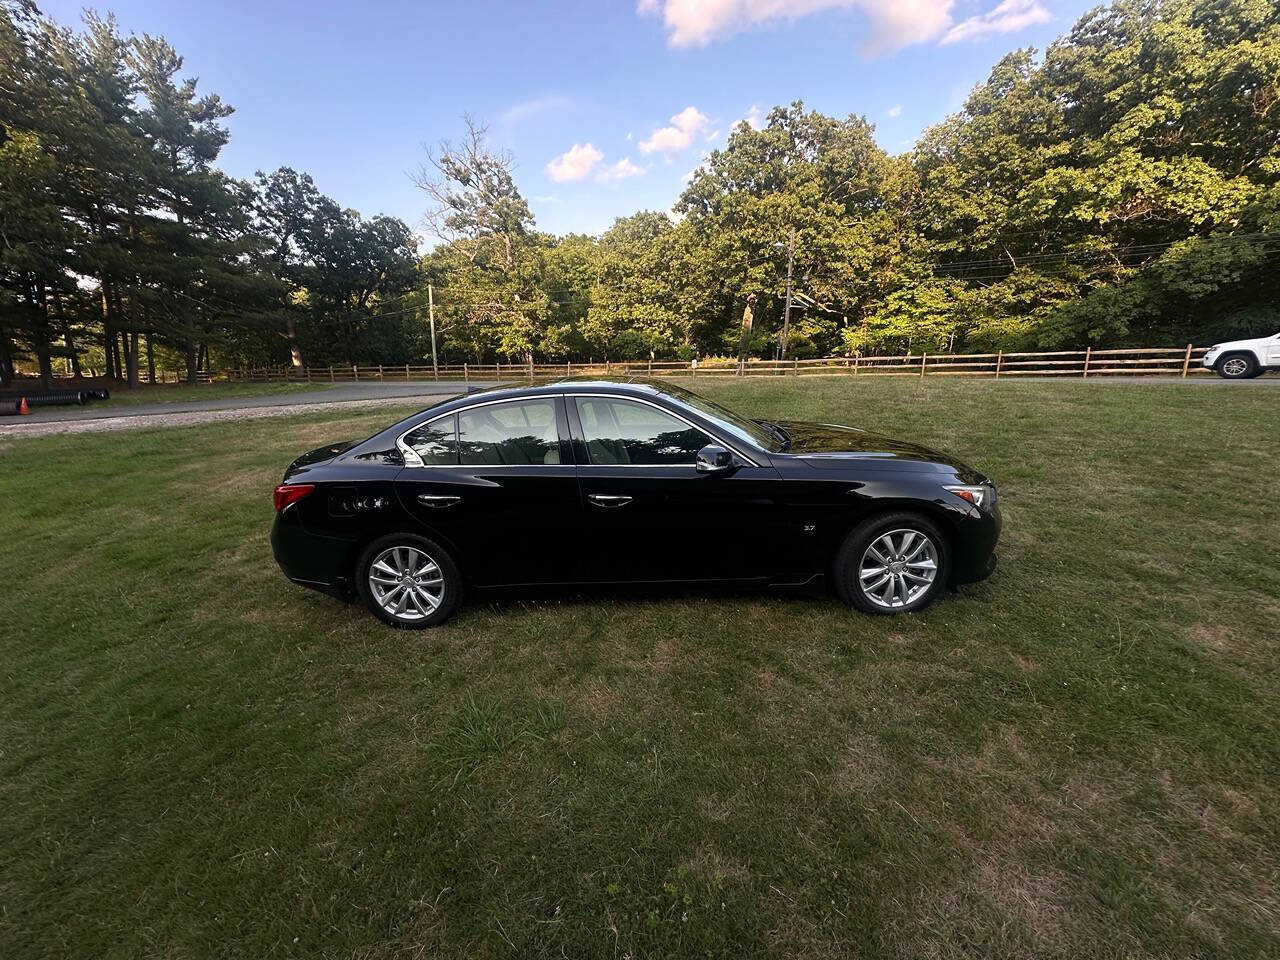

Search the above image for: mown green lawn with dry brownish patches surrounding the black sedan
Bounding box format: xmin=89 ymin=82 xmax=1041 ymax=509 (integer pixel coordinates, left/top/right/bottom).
xmin=0 ymin=379 xmax=1280 ymax=960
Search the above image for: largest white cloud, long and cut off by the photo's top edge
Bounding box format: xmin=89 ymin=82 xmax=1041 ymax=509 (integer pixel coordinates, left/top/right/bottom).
xmin=636 ymin=0 xmax=1048 ymax=54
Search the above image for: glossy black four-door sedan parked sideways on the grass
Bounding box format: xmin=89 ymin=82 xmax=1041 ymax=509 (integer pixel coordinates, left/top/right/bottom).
xmin=271 ymin=379 xmax=1000 ymax=627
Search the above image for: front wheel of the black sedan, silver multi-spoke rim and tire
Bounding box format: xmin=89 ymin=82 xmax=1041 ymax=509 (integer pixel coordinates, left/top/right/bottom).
xmin=832 ymin=512 xmax=950 ymax=613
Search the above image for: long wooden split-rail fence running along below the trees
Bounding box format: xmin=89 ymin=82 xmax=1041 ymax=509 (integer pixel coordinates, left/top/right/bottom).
xmin=227 ymin=343 xmax=1208 ymax=383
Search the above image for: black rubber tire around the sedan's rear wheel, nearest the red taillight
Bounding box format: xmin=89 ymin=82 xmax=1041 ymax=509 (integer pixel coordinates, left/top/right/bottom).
xmin=356 ymin=534 xmax=462 ymax=630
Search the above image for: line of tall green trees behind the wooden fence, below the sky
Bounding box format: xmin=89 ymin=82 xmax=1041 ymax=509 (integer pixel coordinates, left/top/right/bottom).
xmin=0 ymin=0 xmax=1280 ymax=381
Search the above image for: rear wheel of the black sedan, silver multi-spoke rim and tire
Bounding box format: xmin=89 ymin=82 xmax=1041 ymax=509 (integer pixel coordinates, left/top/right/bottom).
xmin=356 ymin=534 xmax=462 ymax=630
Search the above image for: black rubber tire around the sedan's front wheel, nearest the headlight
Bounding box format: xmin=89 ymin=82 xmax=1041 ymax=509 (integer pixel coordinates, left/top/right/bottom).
xmin=831 ymin=511 xmax=951 ymax=614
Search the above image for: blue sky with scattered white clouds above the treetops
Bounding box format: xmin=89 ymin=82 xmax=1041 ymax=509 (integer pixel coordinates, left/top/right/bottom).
xmin=40 ymin=0 xmax=1096 ymax=245
